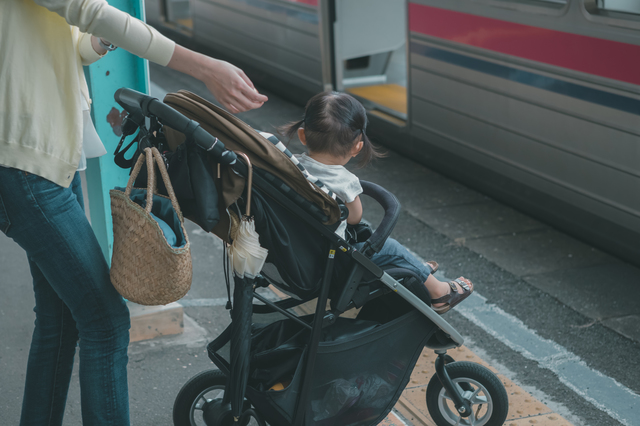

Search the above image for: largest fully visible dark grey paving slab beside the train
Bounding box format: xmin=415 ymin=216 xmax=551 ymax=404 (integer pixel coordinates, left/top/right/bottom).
xmin=459 ymin=229 xmax=620 ymax=277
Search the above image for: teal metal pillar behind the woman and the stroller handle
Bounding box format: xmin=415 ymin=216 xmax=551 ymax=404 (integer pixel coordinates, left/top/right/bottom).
xmin=85 ymin=0 xmax=149 ymax=263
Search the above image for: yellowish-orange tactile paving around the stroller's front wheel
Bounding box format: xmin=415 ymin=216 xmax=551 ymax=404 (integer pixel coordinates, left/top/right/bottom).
xmin=269 ymin=286 xmax=572 ymax=426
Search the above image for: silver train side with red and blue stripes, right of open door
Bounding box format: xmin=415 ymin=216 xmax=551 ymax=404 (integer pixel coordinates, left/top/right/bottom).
xmin=409 ymin=0 xmax=640 ymax=264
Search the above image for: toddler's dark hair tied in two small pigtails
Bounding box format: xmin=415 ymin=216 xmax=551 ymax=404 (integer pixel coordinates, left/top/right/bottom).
xmin=280 ymin=92 xmax=382 ymax=167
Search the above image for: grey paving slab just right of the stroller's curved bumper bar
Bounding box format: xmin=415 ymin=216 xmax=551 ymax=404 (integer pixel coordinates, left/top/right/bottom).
xmin=416 ymin=200 xmax=546 ymax=240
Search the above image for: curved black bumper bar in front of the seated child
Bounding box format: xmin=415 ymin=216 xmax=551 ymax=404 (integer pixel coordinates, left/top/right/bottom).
xmin=360 ymin=180 xmax=400 ymax=255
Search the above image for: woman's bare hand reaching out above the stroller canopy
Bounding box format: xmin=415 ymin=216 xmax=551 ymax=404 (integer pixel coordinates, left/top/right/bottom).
xmin=167 ymin=45 xmax=268 ymax=114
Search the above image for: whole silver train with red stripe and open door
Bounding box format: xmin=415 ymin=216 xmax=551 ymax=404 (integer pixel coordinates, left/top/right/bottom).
xmin=145 ymin=0 xmax=640 ymax=265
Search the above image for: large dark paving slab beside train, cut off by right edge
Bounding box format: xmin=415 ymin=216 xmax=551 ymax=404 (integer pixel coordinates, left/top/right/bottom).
xmin=524 ymin=262 xmax=640 ymax=320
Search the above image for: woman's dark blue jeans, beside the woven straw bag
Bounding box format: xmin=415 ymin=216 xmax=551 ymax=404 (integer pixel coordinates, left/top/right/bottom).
xmin=0 ymin=167 xmax=130 ymax=426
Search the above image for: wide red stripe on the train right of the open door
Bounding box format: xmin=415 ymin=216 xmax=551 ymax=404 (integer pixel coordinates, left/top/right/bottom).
xmin=409 ymin=3 xmax=640 ymax=85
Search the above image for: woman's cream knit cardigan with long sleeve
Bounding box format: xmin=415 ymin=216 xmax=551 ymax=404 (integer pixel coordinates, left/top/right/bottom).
xmin=0 ymin=0 xmax=175 ymax=187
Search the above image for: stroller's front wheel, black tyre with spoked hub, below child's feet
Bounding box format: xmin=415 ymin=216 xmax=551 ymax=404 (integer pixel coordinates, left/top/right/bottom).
xmin=427 ymin=362 xmax=509 ymax=426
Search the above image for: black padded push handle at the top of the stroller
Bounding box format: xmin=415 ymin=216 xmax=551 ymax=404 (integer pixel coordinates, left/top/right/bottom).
xmin=114 ymin=87 xmax=237 ymax=164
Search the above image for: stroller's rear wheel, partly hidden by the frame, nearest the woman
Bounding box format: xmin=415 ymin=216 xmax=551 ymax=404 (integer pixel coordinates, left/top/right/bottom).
xmin=173 ymin=370 xmax=262 ymax=426
